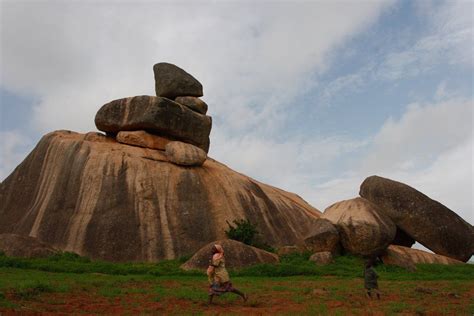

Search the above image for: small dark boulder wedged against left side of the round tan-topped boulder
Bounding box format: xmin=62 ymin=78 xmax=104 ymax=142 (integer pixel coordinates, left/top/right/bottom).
xmin=304 ymin=218 xmax=340 ymax=253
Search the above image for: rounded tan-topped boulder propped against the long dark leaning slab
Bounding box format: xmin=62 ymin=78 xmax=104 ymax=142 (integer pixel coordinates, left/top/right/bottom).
xmin=322 ymin=197 xmax=396 ymax=255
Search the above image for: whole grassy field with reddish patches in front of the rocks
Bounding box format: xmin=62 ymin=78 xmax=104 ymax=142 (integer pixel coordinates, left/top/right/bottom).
xmin=0 ymin=253 xmax=474 ymax=315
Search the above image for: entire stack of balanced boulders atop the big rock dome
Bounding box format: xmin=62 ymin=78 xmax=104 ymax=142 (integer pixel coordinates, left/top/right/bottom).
xmin=95 ymin=63 xmax=212 ymax=166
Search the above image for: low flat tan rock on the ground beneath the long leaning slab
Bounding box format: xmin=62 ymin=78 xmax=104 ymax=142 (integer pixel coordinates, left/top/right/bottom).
xmin=381 ymin=245 xmax=463 ymax=270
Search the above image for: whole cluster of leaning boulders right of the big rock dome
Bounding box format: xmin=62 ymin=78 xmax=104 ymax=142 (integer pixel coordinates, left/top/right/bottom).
xmin=304 ymin=176 xmax=474 ymax=268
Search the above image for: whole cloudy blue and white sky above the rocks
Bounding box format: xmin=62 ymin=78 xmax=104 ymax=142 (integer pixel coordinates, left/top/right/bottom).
xmin=0 ymin=0 xmax=474 ymax=236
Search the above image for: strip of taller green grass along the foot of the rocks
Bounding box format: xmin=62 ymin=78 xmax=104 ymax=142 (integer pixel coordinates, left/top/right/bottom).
xmin=0 ymin=252 xmax=474 ymax=285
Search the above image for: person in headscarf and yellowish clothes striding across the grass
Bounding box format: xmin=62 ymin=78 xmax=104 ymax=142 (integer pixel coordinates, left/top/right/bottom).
xmin=207 ymin=244 xmax=248 ymax=304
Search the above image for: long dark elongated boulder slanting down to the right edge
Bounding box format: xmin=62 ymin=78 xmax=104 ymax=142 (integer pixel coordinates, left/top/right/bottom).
xmin=360 ymin=176 xmax=474 ymax=262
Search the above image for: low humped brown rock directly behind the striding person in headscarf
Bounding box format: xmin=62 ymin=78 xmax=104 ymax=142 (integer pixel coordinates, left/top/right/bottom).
xmin=181 ymin=239 xmax=278 ymax=270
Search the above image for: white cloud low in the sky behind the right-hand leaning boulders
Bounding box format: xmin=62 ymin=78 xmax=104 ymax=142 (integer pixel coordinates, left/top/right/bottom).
xmin=310 ymin=98 xmax=474 ymax=224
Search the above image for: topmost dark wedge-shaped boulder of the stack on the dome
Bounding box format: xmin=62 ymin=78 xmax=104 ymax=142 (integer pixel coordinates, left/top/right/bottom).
xmin=153 ymin=63 xmax=203 ymax=99
